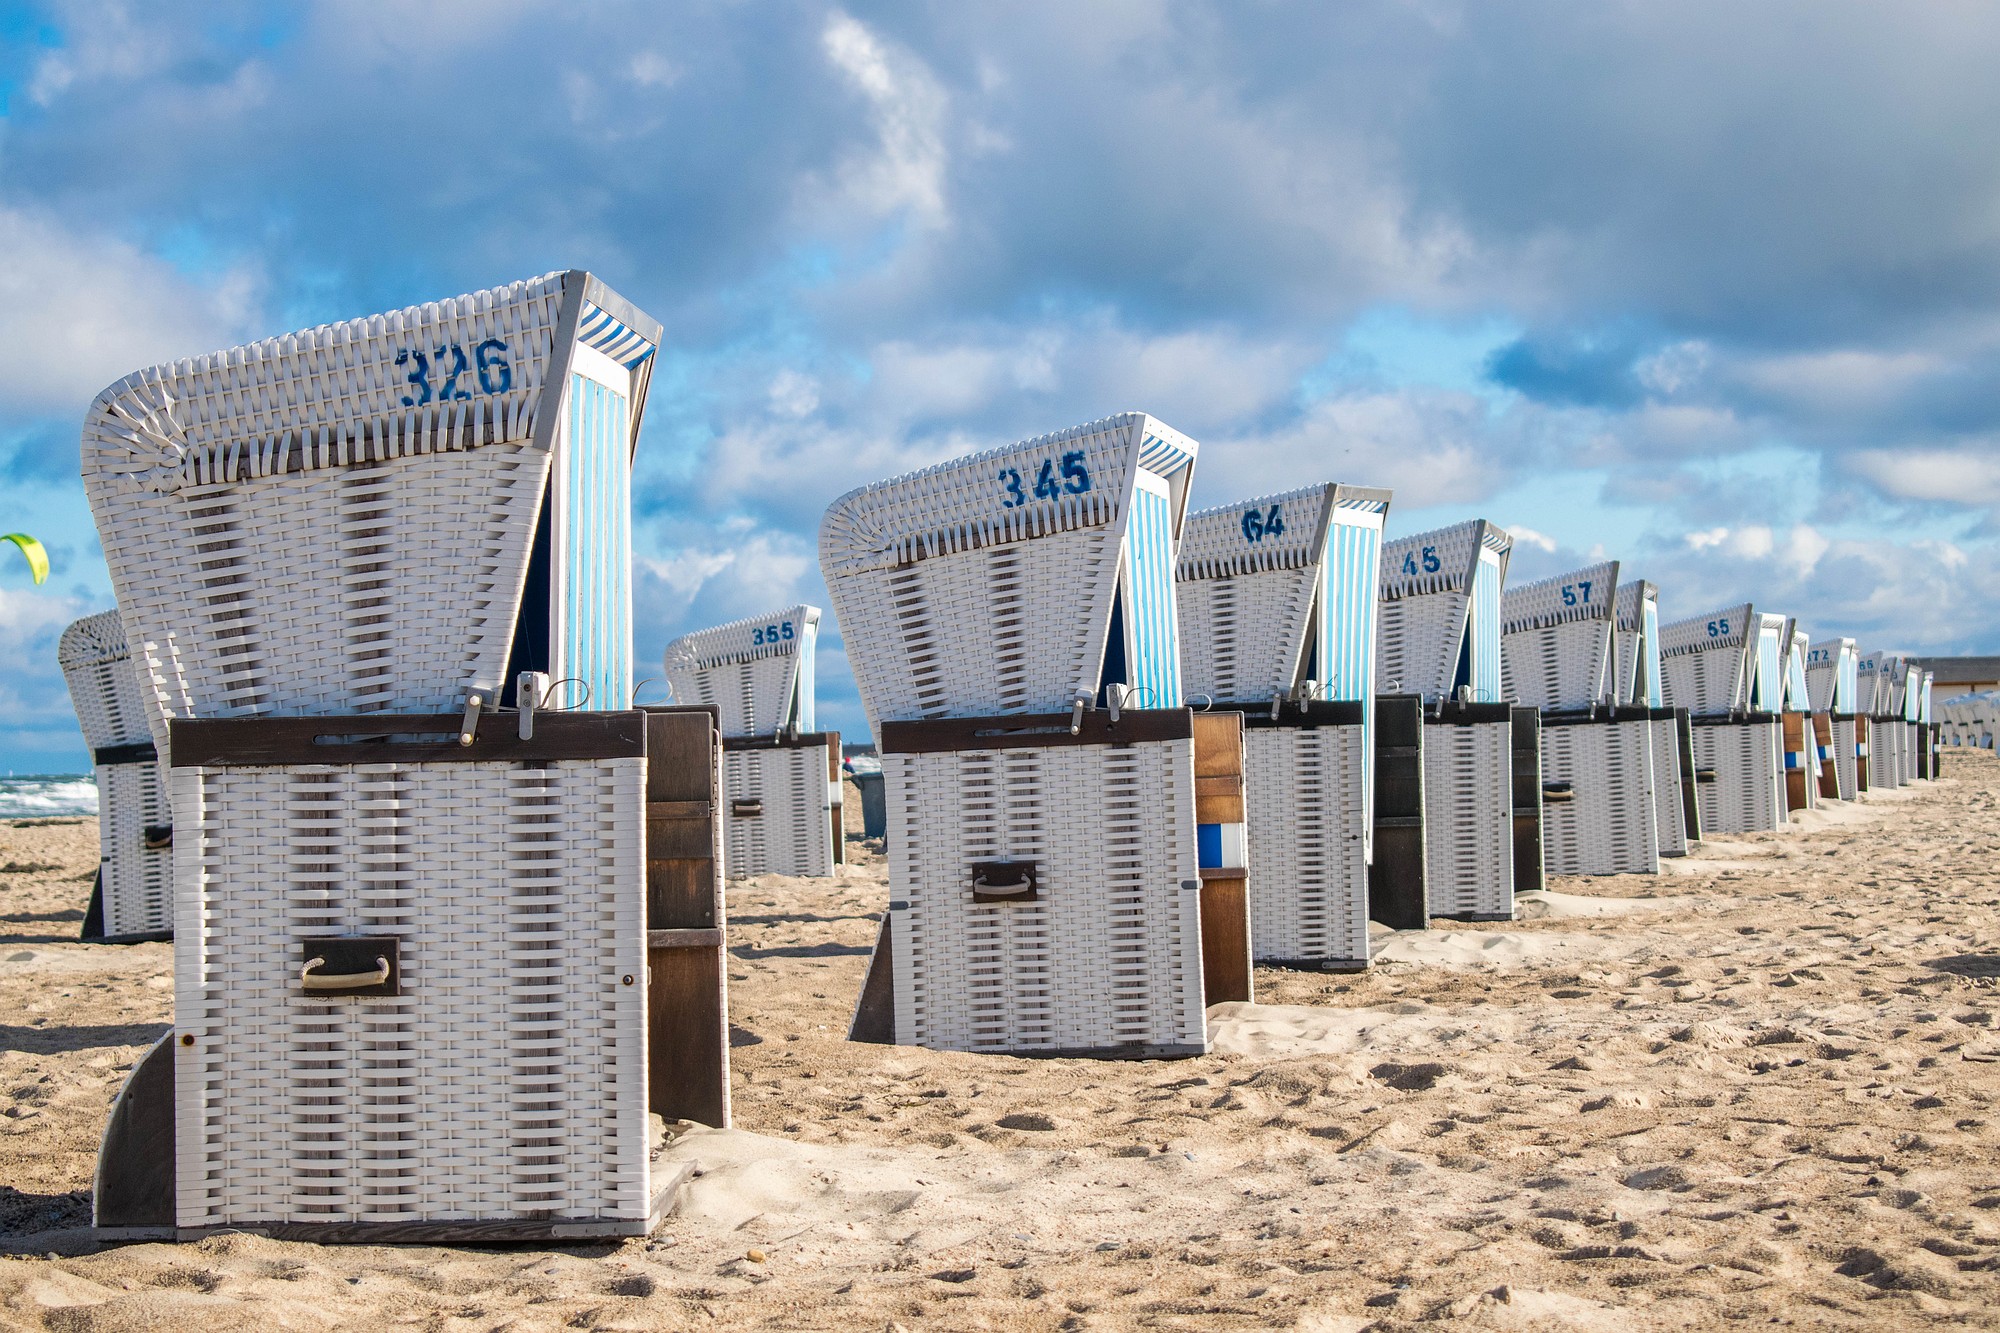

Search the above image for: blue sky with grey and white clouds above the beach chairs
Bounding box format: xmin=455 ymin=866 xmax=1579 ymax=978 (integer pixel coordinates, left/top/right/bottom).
xmin=0 ymin=0 xmax=2000 ymax=773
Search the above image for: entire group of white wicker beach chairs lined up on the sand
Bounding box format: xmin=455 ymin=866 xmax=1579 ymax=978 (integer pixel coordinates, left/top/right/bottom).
xmin=60 ymin=272 xmax=1934 ymax=1241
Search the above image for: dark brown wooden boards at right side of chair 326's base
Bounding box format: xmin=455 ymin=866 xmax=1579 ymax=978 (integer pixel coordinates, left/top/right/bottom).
xmin=646 ymin=709 xmax=730 ymax=1127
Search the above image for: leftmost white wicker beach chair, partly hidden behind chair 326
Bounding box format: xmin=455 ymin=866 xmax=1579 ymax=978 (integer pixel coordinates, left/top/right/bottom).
xmin=56 ymin=610 xmax=174 ymax=943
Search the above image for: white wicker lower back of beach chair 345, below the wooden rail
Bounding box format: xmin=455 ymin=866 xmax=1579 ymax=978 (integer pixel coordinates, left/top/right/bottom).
xmin=882 ymin=741 xmax=1208 ymax=1053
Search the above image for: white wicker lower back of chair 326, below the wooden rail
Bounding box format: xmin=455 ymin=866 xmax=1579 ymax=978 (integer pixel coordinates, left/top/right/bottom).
xmin=172 ymin=759 xmax=650 ymax=1227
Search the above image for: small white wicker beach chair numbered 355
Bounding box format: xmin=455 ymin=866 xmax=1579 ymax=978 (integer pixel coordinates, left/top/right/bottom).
xmin=666 ymin=604 xmax=848 ymax=879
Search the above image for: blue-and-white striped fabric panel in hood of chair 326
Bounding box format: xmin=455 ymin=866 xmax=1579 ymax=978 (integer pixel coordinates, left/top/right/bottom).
xmin=556 ymin=374 xmax=632 ymax=709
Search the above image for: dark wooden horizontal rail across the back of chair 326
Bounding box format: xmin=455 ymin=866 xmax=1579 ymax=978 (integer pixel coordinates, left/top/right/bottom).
xmin=168 ymin=713 xmax=646 ymax=769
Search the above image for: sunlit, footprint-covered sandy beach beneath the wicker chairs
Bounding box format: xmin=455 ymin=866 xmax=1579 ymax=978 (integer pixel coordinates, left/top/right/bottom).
xmin=0 ymin=755 xmax=2000 ymax=1333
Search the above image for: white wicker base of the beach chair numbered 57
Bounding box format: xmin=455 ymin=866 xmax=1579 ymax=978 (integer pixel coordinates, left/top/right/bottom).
xmin=1542 ymin=719 xmax=1672 ymax=875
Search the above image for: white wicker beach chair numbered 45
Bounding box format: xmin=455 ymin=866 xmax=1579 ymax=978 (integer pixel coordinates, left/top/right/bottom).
xmin=1376 ymin=520 xmax=1516 ymax=921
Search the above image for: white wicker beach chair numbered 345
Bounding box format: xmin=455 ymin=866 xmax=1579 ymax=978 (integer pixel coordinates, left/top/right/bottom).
xmin=820 ymin=412 xmax=1250 ymax=1057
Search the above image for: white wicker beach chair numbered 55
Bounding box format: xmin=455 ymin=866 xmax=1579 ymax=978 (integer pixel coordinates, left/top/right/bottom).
xmin=1660 ymin=602 xmax=1786 ymax=835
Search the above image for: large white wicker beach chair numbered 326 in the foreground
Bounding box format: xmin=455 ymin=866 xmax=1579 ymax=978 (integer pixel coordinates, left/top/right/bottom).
xmin=82 ymin=272 xmax=728 ymax=1243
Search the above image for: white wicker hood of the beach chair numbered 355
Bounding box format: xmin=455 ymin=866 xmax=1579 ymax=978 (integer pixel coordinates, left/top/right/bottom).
xmin=666 ymin=604 xmax=820 ymax=737
